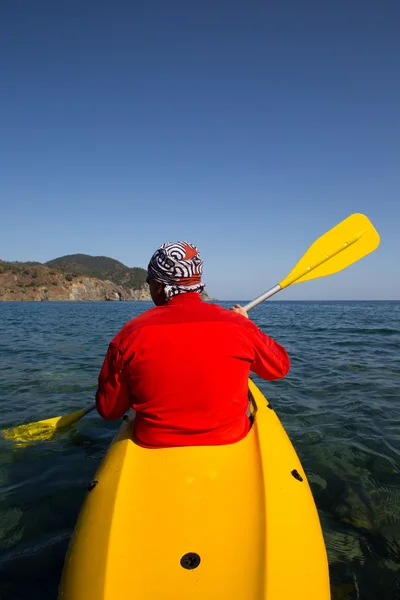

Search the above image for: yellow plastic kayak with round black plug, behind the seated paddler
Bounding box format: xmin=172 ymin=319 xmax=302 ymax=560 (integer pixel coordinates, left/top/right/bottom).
xmin=59 ymin=380 xmax=330 ymax=600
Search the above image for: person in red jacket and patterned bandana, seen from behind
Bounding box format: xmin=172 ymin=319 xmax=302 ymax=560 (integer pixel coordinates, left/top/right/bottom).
xmin=96 ymin=242 xmax=290 ymax=448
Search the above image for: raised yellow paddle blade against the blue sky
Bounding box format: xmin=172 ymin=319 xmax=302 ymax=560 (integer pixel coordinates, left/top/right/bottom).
xmin=279 ymin=213 xmax=379 ymax=288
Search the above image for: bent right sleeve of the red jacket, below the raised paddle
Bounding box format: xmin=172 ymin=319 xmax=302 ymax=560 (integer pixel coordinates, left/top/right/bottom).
xmin=245 ymin=321 xmax=290 ymax=381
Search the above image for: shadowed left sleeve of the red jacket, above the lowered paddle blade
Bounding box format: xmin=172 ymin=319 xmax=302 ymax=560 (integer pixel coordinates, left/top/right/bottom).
xmin=96 ymin=344 xmax=131 ymax=419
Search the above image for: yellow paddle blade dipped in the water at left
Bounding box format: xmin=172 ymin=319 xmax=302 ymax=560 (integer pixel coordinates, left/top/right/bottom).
xmin=1 ymin=410 xmax=87 ymax=442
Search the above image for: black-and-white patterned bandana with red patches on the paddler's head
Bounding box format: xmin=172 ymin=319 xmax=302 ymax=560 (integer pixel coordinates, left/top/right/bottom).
xmin=146 ymin=242 xmax=204 ymax=300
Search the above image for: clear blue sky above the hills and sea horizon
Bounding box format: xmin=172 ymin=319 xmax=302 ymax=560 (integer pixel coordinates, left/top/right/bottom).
xmin=0 ymin=0 xmax=400 ymax=299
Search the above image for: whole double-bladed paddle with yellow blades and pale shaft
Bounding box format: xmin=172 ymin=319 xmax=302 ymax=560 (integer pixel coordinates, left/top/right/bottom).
xmin=2 ymin=213 xmax=379 ymax=441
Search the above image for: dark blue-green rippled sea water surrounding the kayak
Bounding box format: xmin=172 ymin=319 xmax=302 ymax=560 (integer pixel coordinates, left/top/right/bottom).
xmin=0 ymin=302 xmax=400 ymax=600
